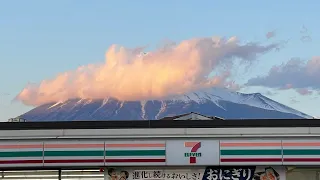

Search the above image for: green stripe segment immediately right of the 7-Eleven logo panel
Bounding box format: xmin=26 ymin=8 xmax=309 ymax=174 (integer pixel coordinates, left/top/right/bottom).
xmin=220 ymin=149 xmax=282 ymax=156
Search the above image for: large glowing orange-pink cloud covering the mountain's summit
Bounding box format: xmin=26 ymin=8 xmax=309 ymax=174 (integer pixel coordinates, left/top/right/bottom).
xmin=16 ymin=37 xmax=277 ymax=105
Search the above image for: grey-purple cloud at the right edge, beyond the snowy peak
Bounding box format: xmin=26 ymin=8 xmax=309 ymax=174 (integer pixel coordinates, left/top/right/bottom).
xmin=246 ymin=56 xmax=320 ymax=95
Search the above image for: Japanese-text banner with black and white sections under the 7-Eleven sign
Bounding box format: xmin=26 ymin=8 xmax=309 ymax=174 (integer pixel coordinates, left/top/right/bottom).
xmin=106 ymin=166 xmax=286 ymax=180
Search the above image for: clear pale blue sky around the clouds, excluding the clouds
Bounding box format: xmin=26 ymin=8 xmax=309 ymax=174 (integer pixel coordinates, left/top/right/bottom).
xmin=0 ymin=0 xmax=320 ymax=121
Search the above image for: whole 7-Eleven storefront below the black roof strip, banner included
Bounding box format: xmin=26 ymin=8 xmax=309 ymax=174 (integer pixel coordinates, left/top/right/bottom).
xmin=0 ymin=121 xmax=320 ymax=180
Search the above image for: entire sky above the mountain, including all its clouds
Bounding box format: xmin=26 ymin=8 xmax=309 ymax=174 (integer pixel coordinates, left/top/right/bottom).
xmin=0 ymin=0 xmax=320 ymax=121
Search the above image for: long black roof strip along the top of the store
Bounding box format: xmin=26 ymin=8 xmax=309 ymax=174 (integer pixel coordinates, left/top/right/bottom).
xmin=0 ymin=119 xmax=320 ymax=130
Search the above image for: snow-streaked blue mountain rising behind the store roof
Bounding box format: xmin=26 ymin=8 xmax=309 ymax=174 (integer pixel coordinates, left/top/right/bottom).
xmin=21 ymin=88 xmax=312 ymax=121
